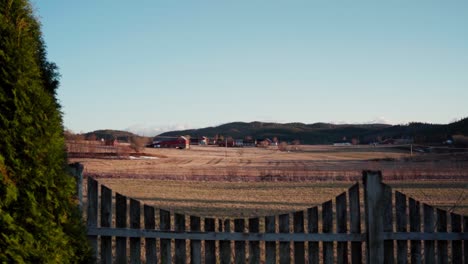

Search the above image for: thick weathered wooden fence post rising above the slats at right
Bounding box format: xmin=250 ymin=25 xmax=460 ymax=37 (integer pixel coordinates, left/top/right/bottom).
xmin=362 ymin=171 xmax=385 ymax=264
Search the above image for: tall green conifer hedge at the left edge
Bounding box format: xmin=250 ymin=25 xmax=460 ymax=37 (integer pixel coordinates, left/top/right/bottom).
xmin=0 ymin=0 xmax=91 ymax=263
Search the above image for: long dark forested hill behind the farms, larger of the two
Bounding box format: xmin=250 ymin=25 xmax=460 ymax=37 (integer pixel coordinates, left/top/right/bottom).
xmin=160 ymin=118 xmax=468 ymax=144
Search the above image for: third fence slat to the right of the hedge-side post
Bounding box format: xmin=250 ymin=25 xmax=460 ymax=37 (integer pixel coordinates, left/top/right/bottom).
xmin=115 ymin=193 xmax=127 ymax=264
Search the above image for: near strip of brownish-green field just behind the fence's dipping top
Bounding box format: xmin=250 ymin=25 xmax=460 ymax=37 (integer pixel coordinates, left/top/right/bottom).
xmin=94 ymin=179 xmax=468 ymax=217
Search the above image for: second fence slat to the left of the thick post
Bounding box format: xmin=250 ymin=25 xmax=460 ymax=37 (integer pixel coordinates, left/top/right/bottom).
xmin=335 ymin=193 xmax=348 ymax=263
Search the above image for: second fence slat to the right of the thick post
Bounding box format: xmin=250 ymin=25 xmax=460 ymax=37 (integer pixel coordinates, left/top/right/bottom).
xmin=395 ymin=191 xmax=408 ymax=264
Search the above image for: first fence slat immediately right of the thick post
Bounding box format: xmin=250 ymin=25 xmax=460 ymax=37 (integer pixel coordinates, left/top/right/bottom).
xmin=382 ymin=184 xmax=395 ymax=264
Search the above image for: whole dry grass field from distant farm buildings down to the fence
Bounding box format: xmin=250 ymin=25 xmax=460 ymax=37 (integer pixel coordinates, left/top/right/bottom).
xmin=71 ymin=146 xmax=468 ymax=217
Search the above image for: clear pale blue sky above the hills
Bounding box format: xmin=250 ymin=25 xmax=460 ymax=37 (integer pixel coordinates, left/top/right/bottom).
xmin=33 ymin=0 xmax=468 ymax=135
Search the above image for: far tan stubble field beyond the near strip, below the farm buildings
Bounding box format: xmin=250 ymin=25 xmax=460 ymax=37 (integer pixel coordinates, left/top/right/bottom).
xmin=71 ymin=146 xmax=468 ymax=181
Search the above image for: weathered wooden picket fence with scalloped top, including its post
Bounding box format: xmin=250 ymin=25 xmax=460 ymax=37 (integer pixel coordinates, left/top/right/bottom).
xmin=87 ymin=171 xmax=468 ymax=263
